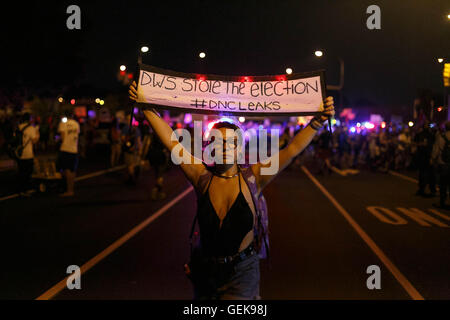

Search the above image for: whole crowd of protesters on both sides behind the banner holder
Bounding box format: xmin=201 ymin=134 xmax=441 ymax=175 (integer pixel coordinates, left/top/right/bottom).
xmin=0 ymin=108 xmax=450 ymax=205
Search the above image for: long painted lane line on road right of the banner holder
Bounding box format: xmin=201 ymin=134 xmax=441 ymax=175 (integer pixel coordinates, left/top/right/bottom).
xmin=302 ymin=166 xmax=424 ymax=300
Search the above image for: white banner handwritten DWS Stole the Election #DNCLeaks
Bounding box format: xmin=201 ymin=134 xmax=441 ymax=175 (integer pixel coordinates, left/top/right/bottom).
xmin=138 ymin=65 xmax=323 ymax=115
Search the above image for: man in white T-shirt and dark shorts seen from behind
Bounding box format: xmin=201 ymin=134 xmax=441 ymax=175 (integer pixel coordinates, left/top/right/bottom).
xmin=58 ymin=113 xmax=80 ymax=197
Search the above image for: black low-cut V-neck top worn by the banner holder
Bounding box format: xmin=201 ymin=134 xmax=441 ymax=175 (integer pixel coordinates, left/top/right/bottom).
xmin=197 ymin=172 xmax=253 ymax=256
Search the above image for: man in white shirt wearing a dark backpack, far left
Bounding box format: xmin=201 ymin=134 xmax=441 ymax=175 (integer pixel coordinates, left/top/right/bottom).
xmin=17 ymin=113 xmax=39 ymax=196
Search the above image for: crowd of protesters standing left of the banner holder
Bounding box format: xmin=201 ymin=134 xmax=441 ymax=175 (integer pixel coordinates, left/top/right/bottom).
xmin=0 ymin=112 xmax=170 ymax=200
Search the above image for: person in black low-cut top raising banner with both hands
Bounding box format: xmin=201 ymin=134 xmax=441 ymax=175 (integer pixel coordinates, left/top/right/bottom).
xmin=129 ymin=82 xmax=334 ymax=300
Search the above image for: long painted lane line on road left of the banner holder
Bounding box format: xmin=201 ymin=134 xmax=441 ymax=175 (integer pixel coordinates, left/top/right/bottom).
xmin=36 ymin=186 xmax=194 ymax=300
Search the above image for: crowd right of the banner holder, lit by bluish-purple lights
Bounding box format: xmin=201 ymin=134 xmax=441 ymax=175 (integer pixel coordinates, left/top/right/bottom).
xmin=297 ymin=121 xmax=450 ymax=207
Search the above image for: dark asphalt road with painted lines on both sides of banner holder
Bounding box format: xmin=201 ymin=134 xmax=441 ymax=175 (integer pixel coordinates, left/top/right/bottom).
xmin=0 ymin=160 xmax=450 ymax=300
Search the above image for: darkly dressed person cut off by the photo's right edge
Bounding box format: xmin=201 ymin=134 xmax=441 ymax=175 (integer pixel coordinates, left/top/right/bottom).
xmin=430 ymin=121 xmax=450 ymax=209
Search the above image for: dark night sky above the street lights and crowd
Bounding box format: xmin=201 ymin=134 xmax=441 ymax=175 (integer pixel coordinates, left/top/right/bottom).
xmin=0 ymin=0 xmax=450 ymax=108
